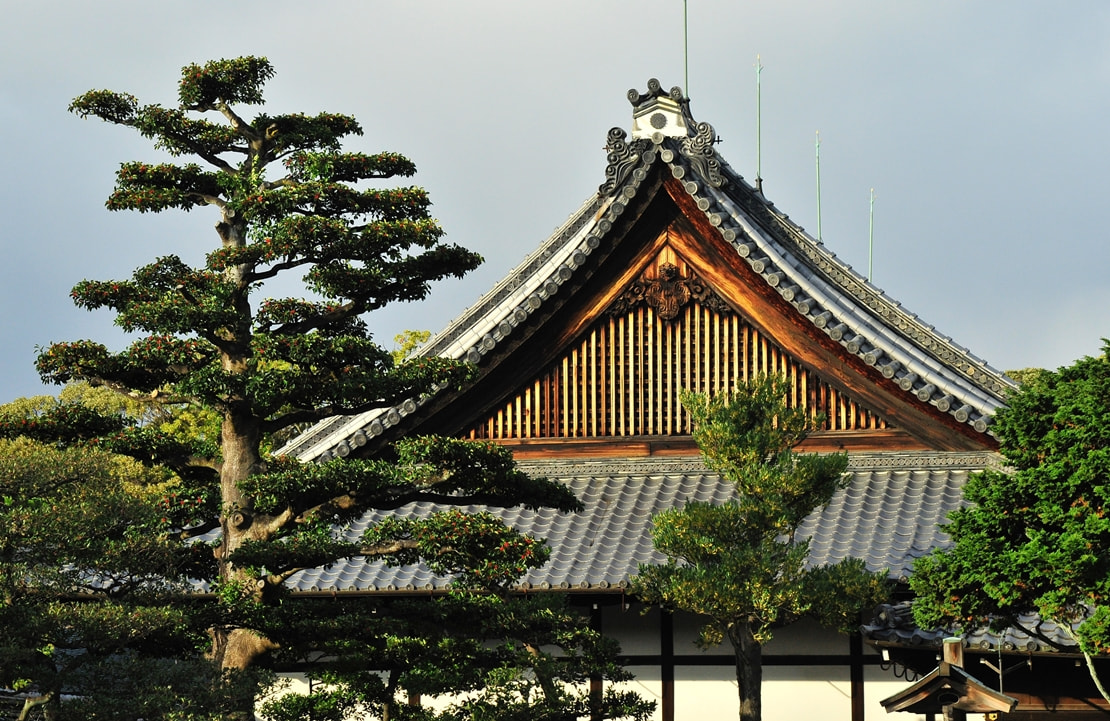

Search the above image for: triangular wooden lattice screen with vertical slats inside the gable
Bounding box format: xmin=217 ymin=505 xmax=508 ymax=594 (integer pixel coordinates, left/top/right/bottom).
xmin=468 ymin=253 xmax=888 ymax=440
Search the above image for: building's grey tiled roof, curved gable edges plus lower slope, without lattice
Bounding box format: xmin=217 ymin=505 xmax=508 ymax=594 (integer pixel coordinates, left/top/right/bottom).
xmin=273 ymin=80 xmax=1015 ymax=592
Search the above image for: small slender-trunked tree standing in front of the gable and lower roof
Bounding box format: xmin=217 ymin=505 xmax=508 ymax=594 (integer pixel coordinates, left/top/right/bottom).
xmin=634 ymin=376 xmax=887 ymax=721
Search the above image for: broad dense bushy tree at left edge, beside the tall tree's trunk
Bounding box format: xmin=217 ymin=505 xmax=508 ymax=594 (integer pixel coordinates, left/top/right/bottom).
xmin=0 ymin=419 xmax=246 ymax=719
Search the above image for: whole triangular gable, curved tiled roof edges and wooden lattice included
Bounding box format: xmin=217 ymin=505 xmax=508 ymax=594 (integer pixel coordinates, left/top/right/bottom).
xmin=283 ymin=78 xmax=1013 ymax=460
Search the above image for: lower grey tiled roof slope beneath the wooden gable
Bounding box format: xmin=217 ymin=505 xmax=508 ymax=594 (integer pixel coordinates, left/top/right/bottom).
xmin=289 ymin=453 xmax=998 ymax=592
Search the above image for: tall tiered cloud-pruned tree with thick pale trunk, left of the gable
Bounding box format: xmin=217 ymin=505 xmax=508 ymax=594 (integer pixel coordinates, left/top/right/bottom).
xmin=0 ymin=58 xmax=648 ymax=719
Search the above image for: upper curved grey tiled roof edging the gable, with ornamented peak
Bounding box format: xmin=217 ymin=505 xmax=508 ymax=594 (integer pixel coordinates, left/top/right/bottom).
xmin=281 ymin=80 xmax=1013 ymax=460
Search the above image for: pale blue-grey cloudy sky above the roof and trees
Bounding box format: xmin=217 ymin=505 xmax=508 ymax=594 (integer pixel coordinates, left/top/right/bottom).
xmin=0 ymin=0 xmax=1110 ymax=403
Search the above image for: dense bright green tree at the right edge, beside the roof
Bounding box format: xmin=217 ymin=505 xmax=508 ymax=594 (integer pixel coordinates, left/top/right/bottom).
xmin=910 ymin=344 xmax=1110 ymax=700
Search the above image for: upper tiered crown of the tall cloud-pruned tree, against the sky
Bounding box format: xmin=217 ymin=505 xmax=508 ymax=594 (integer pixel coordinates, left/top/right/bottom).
xmin=54 ymin=58 xmax=481 ymax=421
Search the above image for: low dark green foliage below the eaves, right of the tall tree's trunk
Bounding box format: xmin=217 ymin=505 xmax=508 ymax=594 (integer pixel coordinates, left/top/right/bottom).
xmin=262 ymin=592 xmax=654 ymax=721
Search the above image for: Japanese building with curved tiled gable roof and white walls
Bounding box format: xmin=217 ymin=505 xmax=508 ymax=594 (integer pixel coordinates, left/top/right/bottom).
xmin=283 ymin=80 xmax=1038 ymax=721
